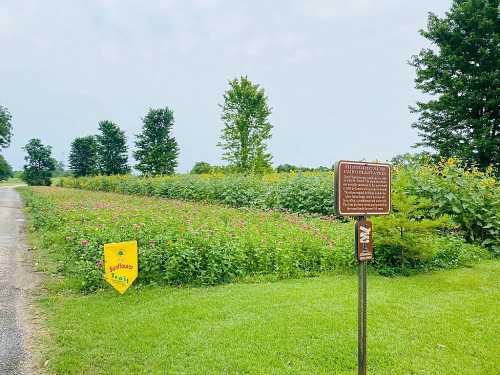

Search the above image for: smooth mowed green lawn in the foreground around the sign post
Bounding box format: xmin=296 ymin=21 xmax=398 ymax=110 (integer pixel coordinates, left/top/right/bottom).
xmin=41 ymin=261 xmax=500 ymax=375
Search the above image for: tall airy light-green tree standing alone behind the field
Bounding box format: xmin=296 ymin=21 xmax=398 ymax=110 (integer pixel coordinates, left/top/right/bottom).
xmin=217 ymin=77 xmax=272 ymax=172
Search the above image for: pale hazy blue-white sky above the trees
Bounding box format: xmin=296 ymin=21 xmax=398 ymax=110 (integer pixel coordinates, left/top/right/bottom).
xmin=0 ymin=0 xmax=451 ymax=172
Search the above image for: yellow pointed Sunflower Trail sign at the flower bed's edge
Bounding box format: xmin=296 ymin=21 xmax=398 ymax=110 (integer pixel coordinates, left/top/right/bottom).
xmin=104 ymin=241 xmax=137 ymax=294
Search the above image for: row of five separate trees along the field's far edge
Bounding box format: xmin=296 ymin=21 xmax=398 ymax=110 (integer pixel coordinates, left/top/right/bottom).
xmin=16 ymin=76 xmax=272 ymax=185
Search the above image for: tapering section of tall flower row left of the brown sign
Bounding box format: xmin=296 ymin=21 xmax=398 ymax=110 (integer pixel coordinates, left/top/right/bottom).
xmin=57 ymin=173 xmax=334 ymax=215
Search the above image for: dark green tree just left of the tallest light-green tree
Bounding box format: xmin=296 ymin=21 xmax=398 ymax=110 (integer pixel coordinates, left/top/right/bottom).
xmin=134 ymin=107 xmax=179 ymax=175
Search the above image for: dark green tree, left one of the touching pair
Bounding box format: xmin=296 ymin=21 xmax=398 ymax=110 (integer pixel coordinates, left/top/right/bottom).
xmin=69 ymin=135 xmax=97 ymax=177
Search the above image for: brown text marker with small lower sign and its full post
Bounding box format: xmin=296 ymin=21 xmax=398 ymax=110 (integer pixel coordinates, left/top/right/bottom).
xmin=335 ymin=161 xmax=391 ymax=375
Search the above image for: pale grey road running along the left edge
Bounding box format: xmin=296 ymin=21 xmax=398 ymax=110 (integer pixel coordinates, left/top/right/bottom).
xmin=0 ymin=187 xmax=37 ymax=375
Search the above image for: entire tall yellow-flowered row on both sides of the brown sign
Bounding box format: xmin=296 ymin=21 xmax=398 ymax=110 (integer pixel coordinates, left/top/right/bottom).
xmin=58 ymin=163 xmax=500 ymax=255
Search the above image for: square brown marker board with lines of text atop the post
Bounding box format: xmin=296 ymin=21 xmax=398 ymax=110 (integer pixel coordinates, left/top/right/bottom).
xmin=335 ymin=160 xmax=391 ymax=216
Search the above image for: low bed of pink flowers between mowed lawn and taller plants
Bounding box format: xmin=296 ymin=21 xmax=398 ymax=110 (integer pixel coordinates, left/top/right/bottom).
xmin=19 ymin=187 xmax=488 ymax=291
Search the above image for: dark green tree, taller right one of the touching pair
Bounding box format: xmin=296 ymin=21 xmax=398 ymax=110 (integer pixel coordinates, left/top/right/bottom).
xmin=96 ymin=120 xmax=130 ymax=176
